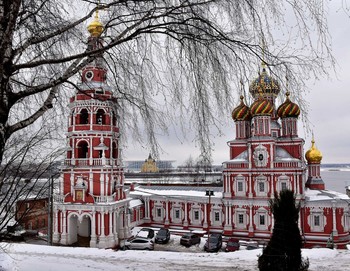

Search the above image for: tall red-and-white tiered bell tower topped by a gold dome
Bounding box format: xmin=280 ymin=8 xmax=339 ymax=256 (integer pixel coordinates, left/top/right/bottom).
xmin=53 ymin=12 xmax=128 ymax=248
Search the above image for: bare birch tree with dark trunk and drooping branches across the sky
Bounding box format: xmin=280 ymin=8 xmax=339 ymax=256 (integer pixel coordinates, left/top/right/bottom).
xmin=0 ymin=0 xmax=334 ymax=166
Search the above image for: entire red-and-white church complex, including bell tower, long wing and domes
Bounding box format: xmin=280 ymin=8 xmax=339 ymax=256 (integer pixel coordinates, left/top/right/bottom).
xmin=53 ymin=14 xmax=350 ymax=251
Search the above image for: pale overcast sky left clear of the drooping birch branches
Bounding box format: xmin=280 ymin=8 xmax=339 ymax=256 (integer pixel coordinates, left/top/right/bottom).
xmin=124 ymin=0 xmax=350 ymax=165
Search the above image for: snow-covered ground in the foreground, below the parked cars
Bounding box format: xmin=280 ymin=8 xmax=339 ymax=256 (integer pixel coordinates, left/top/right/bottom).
xmin=0 ymin=236 xmax=350 ymax=271
